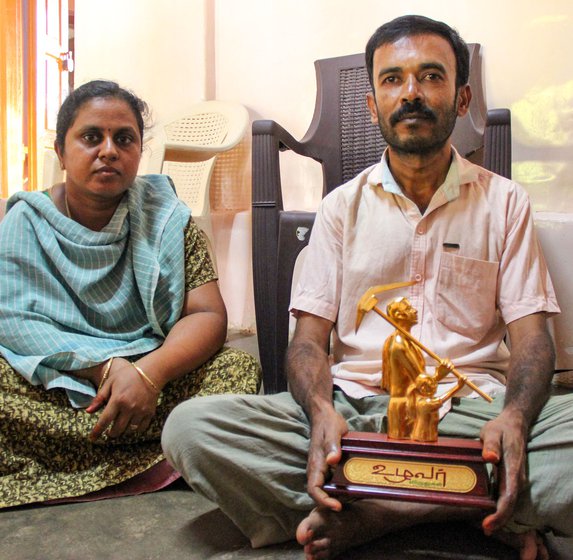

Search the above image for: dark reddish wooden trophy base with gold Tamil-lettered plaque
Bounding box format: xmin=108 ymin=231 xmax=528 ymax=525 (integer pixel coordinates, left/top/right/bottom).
xmin=324 ymin=432 xmax=496 ymax=510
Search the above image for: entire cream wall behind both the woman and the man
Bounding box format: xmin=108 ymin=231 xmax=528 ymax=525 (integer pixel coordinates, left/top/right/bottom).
xmin=76 ymin=0 xmax=573 ymax=327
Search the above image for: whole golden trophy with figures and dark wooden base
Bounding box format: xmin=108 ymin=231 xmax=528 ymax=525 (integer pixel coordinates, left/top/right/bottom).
xmin=324 ymin=282 xmax=496 ymax=510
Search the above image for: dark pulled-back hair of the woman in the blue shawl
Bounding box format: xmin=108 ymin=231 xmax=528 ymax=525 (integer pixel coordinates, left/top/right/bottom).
xmin=56 ymin=80 xmax=149 ymax=153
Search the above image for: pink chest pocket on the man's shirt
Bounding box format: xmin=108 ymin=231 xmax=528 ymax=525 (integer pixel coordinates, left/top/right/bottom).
xmin=435 ymin=252 xmax=499 ymax=341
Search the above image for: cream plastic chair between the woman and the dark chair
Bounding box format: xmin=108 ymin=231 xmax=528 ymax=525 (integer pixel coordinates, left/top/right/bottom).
xmin=153 ymin=101 xmax=249 ymax=262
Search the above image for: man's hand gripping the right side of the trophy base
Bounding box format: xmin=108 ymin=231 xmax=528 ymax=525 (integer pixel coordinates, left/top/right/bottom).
xmin=480 ymin=407 xmax=527 ymax=535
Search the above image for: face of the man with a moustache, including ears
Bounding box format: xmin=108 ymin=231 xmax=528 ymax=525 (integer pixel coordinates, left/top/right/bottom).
xmin=368 ymin=34 xmax=471 ymax=155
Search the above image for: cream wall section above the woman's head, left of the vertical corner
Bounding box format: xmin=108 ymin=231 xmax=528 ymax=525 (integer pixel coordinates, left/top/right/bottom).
xmin=74 ymin=0 xmax=207 ymax=171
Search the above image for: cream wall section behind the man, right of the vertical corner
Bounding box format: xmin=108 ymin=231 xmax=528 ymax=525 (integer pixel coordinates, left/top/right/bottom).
xmin=216 ymin=0 xmax=573 ymax=211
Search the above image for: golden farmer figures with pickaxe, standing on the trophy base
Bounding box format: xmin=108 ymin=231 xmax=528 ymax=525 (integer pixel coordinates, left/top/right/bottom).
xmin=356 ymin=282 xmax=491 ymax=442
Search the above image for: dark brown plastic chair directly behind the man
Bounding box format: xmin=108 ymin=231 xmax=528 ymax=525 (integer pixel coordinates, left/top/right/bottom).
xmin=252 ymin=44 xmax=511 ymax=394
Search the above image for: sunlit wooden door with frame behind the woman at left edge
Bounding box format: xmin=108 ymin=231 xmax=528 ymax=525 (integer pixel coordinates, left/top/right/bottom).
xmin=0 ymin=0 xmax=73 ymax=197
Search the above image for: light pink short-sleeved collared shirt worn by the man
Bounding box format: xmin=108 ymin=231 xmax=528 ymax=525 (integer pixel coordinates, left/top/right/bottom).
xmin=291 ymin=151 xmax=559 ymax=397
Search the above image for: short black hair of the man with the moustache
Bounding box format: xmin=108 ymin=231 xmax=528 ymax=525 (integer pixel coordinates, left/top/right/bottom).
xmin=366 ymin=15 xmax=470 ymax=89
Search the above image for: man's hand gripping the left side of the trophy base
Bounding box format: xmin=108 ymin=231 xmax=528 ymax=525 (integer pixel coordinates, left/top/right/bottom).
xmin=306 ymin=408 xmax=348 ymax=511
